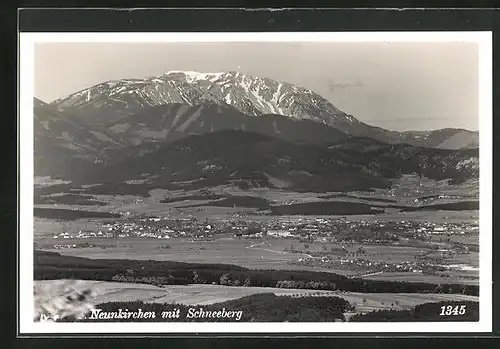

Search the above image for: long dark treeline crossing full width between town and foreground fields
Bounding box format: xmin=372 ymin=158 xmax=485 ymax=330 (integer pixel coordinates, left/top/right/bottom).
xmin=34 ymin=251 xmax=479 ymax=296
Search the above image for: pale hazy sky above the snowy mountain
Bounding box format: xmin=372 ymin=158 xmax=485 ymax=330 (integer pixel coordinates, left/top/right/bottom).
xmin=35 ymin=42 xmax=478 ymax=131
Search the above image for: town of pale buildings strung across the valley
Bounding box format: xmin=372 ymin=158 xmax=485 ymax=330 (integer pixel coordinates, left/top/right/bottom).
xmin=48 ymin=213 xmax=479 ymax=249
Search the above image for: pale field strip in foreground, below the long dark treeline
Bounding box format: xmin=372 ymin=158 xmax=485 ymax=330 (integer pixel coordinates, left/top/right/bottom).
xmin=35 ymin=280 xmax=479 ymax=312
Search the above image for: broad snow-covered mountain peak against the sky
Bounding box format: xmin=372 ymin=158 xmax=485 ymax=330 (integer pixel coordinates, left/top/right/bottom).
xmin=53 ymin=70 xmax=360 ymax=126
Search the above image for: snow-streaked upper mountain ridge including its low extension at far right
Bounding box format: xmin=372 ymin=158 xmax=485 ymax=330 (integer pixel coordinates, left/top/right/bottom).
xmin=47 ymin=71 xmax=478 ymax=149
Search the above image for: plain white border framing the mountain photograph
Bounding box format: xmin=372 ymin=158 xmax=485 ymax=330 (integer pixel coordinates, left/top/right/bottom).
xmin=17 ymin=31 xmax=493 ymax=335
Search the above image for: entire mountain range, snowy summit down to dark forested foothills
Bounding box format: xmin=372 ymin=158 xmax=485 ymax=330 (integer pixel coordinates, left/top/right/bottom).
xmin=34 ymin=71 xmax=479 ymax=191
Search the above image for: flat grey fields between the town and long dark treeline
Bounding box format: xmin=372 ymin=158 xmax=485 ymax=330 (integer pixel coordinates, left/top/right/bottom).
xmin=36 ymin=235 xmax=479 ymax=284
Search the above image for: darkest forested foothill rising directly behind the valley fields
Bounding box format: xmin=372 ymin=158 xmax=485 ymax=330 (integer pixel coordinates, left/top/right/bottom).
xmin=82 ymin=131 xmax=479 ymax=192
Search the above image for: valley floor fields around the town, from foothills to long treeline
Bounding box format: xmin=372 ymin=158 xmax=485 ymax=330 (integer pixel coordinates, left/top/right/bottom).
xmin=34 ymin=175 xmax=479 ymax=285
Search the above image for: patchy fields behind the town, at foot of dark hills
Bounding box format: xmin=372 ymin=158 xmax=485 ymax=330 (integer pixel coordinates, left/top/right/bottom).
xmin=33 ymin=175 xmax=479 ymax=221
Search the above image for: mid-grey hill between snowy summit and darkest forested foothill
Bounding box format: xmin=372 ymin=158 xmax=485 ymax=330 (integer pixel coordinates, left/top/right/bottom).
xmin=99 ymin=103 xmax=348 ymax=145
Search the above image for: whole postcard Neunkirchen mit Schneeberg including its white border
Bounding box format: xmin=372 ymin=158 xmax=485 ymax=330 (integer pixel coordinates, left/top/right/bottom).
xmin=18 ymin=32 xmax=492 ymax=334
